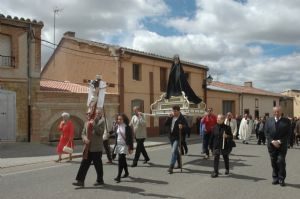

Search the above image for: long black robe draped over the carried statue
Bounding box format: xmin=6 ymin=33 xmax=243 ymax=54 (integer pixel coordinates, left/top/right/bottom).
xmin=166 ymin=57 xmax=202 ymax=104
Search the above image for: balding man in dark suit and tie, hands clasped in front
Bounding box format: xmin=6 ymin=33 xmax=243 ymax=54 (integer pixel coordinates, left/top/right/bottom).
xmin=264 ymin=107 xmax=291 ymax=186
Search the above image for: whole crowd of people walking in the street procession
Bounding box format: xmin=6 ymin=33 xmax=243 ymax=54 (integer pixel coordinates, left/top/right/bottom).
xmin=57 ymin=106 xmax=300 ymax=186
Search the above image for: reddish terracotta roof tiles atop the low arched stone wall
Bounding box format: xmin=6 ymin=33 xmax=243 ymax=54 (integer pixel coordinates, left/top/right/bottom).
xmin=40 ymin=80 xmax=88 ymax=93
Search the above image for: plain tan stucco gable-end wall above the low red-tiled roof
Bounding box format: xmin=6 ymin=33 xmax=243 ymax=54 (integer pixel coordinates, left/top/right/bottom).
xmin=42 ymin=38 xmax=118 ymax=93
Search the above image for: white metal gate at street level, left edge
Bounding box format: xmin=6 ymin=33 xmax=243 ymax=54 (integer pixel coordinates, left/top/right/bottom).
xmin=0 ymin=89 xmax=16 ymax=141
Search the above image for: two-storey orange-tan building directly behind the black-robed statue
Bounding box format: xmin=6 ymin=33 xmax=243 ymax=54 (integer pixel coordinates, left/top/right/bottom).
xmin=41 ymin=32 xmax=208 ymax=136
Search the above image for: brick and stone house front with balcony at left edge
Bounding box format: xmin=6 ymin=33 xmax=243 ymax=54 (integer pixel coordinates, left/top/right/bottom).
xmin=0 ymin=14 xmax=43 ymax=141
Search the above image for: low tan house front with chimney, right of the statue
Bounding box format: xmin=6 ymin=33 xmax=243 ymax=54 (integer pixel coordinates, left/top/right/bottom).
xmin=208 ymin=81 xmax=282 ymax=118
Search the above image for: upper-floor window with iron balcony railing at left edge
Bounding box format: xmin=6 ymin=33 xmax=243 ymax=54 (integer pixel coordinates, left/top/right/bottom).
xmin=0 ymin=34 xmax=15 ymax=67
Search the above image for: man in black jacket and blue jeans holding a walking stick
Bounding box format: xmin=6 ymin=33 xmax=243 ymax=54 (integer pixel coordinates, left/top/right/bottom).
xmin=165 ymin=105 xmax=188 ymax=174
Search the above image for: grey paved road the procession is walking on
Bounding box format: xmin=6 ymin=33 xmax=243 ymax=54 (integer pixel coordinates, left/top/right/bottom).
xmin=0 ymin=138 xmax=300 ymax=199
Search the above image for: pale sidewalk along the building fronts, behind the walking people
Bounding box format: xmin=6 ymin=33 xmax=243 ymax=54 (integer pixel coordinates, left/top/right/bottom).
xmin=0 ymin=134 xmax=200 ymax=169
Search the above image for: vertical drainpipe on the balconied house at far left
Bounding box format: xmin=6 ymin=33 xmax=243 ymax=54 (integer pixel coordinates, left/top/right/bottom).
xmin=27 ymin=24 xmax=32 ymax=142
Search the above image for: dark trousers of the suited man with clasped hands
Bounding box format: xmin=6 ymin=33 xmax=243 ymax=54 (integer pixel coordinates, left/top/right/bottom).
xmin=269 ymin=149 xmax=286 ymax=180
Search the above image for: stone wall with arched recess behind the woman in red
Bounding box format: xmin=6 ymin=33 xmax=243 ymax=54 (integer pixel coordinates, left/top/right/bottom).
xmin=31 ymin=91 xmax=119 ymax=142
